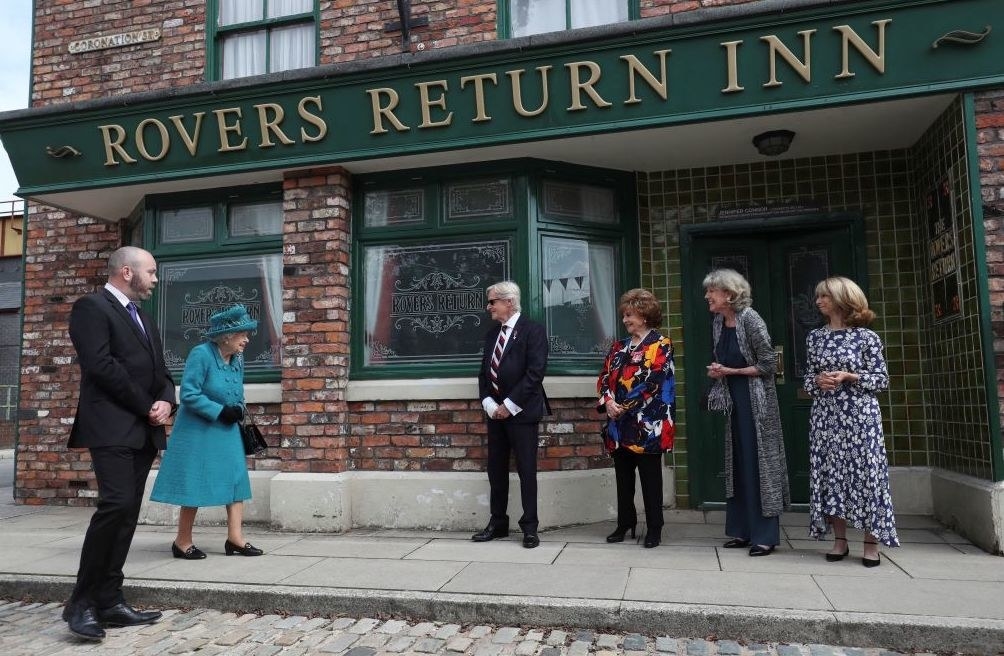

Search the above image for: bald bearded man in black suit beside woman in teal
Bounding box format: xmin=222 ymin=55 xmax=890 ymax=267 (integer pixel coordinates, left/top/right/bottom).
xmin=62 ymin=246 xmax=177 ymax=640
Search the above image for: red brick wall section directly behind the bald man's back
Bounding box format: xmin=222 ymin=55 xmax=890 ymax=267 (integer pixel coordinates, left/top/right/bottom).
xmin=14 ymin=206 xmax=120 ymax=505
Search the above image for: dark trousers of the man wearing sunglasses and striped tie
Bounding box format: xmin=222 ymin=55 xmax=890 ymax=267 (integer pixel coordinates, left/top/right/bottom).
xmin=488 ymin=419 xmax=540 ymax=533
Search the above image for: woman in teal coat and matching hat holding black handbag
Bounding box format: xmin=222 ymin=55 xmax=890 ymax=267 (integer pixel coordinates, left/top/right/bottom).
xmin=150 ymin=305 xmax=262 ymax=561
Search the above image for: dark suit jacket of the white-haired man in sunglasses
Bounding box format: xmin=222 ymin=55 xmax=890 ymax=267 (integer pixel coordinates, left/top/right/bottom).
xmin=478 ymin=314 xmax=550 ymax=423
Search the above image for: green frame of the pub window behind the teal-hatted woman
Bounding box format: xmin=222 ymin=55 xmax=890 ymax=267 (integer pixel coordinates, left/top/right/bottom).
xmin=133 ymin=184 xmax=283 ymax=384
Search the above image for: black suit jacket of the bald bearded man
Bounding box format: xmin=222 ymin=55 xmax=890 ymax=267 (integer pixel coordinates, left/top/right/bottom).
xmin=68 ymin=289 xmax=177 ymax=449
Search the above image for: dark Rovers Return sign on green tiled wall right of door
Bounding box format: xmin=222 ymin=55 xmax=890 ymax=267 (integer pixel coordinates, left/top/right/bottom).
xmin=924 ymin=177 xmax=962 ymax=323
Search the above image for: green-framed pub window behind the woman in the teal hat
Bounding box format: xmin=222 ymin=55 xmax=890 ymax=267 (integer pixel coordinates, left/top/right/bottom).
xmin=140 ymin=186 xmax=282 ymax=382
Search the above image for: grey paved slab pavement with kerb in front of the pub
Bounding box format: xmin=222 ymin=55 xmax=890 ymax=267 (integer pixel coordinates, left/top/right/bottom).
xmin=0 ymin=468 xmax=1004 ymax=654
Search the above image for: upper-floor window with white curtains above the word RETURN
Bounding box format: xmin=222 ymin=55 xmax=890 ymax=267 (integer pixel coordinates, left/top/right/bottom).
xmin=499 ymin=0 xmax=640 ymax=37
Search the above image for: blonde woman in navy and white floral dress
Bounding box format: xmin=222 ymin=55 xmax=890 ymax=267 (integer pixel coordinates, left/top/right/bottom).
xmin=805 ymin=276 xmax=900 ymax=568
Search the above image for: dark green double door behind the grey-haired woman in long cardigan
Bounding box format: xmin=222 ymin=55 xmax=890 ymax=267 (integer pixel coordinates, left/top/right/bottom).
xmin=682 ymin=217 xmax=864 ymax=507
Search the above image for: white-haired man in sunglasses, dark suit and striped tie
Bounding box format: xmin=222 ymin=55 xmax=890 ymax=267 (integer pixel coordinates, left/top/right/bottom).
xmin=471 ymin=280 xmax=550 ymax=549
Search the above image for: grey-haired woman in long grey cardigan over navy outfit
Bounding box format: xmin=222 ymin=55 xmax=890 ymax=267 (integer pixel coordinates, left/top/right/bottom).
xmin=704 ymin=269 xmax=790 ymax=556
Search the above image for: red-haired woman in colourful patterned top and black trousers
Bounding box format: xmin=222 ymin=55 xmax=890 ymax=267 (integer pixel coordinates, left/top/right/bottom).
xmin=596 ymin=289 xmax=677 ymax=549
